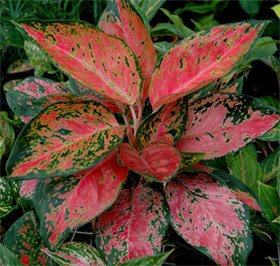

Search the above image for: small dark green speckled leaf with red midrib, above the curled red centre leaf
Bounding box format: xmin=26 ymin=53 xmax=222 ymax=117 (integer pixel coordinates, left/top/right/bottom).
xmin=136 ymin=98 xmax=188 ymax=147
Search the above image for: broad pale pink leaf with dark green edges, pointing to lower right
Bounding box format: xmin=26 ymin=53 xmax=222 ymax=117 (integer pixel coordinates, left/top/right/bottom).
xmin=165 ymin=173 xmax=252 ymax=265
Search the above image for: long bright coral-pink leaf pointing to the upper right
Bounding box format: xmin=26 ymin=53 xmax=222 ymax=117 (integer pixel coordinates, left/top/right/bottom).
xmin=149 ymin=22 xmax=264 ymax=110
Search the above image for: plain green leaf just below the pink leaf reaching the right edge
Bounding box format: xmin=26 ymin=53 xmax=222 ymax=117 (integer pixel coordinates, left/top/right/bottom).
xmin=226 ymin=144 xmax=263 ymax=193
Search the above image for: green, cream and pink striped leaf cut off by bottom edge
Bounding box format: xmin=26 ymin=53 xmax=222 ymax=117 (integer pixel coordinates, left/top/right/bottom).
xmin=42 ymin=242 xmax=105 ymax=266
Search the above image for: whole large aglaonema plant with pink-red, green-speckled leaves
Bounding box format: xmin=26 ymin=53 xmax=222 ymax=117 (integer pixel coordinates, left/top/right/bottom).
xmin=4 ymin=0 xmax=279 ymax=265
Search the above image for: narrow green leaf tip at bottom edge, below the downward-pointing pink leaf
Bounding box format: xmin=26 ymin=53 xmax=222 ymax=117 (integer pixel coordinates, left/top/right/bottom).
xmin=120 ymin=249 xmax=174 ymax=266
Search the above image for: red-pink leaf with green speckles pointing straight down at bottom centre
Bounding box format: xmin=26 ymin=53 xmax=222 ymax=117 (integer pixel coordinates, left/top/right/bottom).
xmin=96 ymin=184 xmax=168 ymax=265
